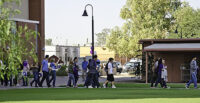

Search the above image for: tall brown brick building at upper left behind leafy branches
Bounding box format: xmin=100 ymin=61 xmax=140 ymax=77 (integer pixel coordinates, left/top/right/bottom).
xmin=11 ymin=0 xmax=45 ymax=62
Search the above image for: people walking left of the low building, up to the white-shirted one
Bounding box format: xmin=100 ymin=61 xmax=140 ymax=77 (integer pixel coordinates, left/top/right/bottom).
xmin=1 ymin=55 xmax=116 ymax=88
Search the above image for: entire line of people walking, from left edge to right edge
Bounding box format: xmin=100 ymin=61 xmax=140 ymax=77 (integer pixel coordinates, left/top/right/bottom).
xmin=0 ymin=55 xmax=199 ymax=88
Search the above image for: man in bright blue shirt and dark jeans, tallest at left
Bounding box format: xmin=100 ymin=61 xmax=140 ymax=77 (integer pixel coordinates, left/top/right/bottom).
xmin=39 ymin=55 xmax=51 ymax=87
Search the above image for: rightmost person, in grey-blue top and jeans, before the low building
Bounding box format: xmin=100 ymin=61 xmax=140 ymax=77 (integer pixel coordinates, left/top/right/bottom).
xmin=185 ymin=57 xmax=198 ymax=89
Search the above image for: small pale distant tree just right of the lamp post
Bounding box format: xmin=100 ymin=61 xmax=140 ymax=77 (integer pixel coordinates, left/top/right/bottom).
xmin=96 ymin=29 xmax=110 ymax=46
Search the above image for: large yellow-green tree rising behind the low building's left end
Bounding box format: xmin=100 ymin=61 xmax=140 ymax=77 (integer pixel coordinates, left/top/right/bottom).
xmin=120 ymin=0 xmax=183 ymax=57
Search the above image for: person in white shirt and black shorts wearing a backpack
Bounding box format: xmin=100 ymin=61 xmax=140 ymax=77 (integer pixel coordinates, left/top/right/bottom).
xmin=103 ymin=58 xmax=116 ymax=88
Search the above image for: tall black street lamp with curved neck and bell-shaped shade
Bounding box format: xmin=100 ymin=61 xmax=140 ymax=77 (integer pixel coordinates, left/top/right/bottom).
xmin=82 ymin=4 xmax=94 ymax=58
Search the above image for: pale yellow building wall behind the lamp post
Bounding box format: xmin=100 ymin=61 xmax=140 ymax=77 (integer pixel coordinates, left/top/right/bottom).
xmin=80 ymin=47 xmax=115 ymax=61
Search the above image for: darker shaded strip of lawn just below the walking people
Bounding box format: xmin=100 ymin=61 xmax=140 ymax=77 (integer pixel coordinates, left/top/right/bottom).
xmin=0 ymin=88 xmax=200 ymax=102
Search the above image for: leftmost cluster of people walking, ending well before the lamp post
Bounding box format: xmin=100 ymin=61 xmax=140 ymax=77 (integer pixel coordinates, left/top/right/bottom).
xmin=1 ymin=55 xmax=59 ymax=87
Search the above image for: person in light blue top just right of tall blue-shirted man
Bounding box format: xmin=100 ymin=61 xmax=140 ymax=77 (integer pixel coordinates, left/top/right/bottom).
xmin=49 ymin=59 xmax=60 ymax=87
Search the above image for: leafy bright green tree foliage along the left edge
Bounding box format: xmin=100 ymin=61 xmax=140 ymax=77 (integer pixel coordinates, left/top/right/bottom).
xmin=0 ymin=0 xmax=37 ymax=78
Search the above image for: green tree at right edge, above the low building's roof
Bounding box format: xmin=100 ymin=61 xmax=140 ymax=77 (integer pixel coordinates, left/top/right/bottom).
xmin=170 ymin=3 xmax=200 ymax=38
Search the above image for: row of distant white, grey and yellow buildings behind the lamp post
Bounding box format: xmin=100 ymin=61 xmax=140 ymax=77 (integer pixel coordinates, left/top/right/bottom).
xmin=45 ymin=45 xmax=115 ymax=64
